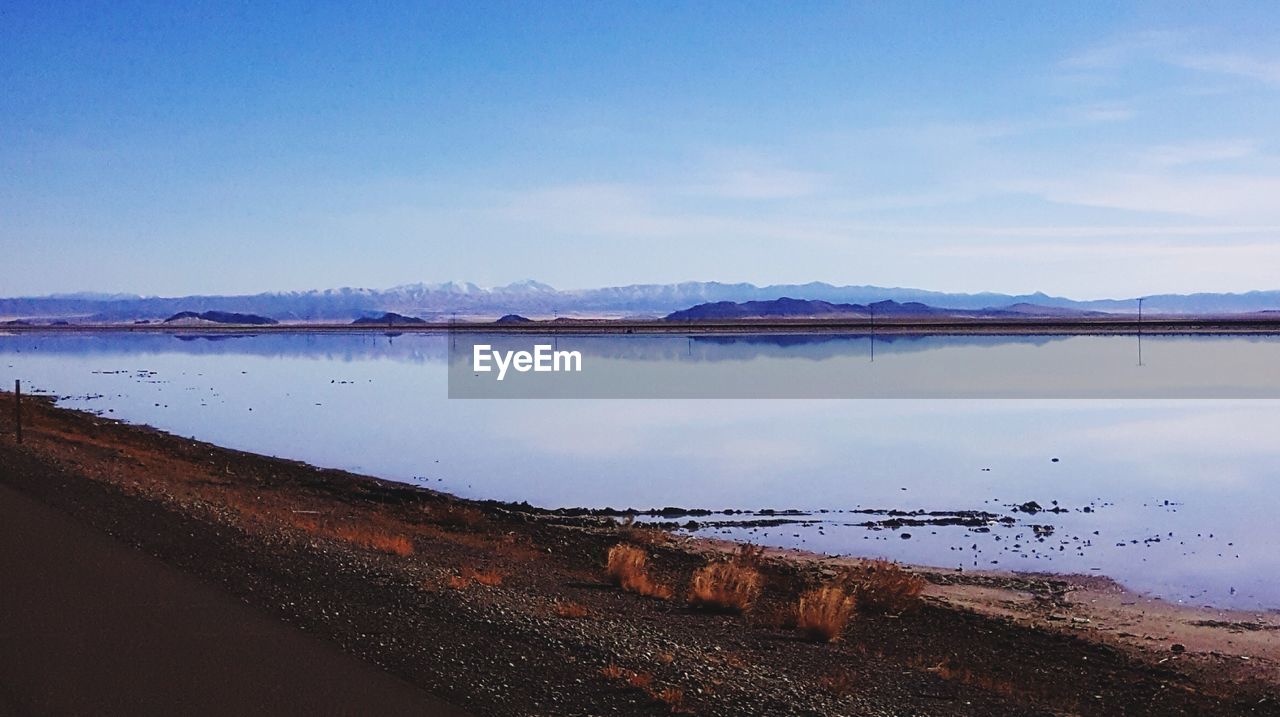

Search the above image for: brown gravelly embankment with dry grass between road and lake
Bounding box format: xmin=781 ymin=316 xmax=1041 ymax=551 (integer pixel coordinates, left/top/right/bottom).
xmin=0 ymin=394 xmax=1280 ymax=716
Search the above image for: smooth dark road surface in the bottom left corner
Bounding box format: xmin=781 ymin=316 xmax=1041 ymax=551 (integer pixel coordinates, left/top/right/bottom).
xmin=0 ymin=476 xmax=466 ymax=717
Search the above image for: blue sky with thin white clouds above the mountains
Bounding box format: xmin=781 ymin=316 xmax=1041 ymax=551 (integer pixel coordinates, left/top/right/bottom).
xmin=0 ymin=0 xmax=1280 ymax=298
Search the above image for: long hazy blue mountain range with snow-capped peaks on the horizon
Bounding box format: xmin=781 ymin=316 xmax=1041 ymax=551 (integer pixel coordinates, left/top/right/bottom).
xmin=0 ymin=280 xmax=1280 ymax=323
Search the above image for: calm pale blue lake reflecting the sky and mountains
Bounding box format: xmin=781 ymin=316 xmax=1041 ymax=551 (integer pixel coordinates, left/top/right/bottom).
xmin=0 ymin=333 xmax=1280 ymax=609
